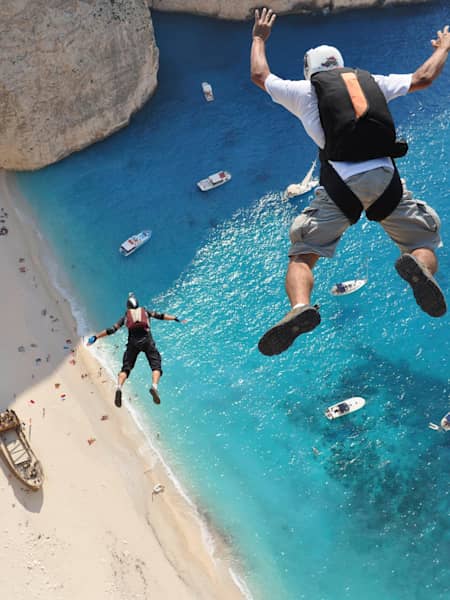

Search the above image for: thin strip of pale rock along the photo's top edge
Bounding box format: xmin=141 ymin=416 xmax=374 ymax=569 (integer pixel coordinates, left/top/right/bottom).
xmin=148 ymin=0 xmax=431 ymax=20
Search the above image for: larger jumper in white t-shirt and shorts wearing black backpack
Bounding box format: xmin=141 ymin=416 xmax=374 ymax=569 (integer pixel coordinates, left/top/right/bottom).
xmin=250 ymin=8 xmax=450 ymax=356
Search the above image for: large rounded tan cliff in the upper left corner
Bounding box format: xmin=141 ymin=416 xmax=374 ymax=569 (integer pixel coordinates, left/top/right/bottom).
xmin=0 ymin=0 xmax=158 ymax=170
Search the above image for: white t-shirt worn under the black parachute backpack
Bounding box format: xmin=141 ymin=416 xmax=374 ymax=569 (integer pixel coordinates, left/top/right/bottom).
xmin=264 ymin=73 xmax=412 ymax=181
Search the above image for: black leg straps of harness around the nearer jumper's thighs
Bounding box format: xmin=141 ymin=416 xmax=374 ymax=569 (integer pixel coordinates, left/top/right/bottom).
xmin=320 ymin=160 xmax=403 ymax=225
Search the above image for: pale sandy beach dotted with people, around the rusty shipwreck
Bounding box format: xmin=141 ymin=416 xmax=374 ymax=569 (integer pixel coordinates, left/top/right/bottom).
xmin=0 ymin=173 xmax=244 ymax=600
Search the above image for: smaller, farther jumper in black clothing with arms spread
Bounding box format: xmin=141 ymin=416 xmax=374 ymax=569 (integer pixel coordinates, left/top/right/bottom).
xmin=87 ymin=293 xmax=186 ymax=407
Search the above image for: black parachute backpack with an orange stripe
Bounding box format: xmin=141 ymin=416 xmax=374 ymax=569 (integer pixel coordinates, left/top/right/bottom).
xmin=311 ymin=67 xmax=408 ymax=162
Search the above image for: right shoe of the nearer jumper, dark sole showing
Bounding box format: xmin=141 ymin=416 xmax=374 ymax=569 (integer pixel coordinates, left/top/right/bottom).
xmin=395 ymin=254 xmax=447 ymax=317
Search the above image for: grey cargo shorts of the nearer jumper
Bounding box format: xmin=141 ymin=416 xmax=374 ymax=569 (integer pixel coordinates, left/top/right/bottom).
xmin=288 ymin=167 xmax=442 ymax=258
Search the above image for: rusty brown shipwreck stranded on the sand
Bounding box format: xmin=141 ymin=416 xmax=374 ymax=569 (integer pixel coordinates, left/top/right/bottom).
xmin=0 ymin=409 xmax=44 ymax=491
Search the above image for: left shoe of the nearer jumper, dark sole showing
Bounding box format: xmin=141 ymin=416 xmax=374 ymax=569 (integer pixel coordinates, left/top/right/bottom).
xmin=258 ymin=304 xmax=320 ymax=356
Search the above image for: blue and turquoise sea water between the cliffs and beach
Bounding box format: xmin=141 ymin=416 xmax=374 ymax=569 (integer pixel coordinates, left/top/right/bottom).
xmin=15 ymin=1 xmax=450 ymax=600
